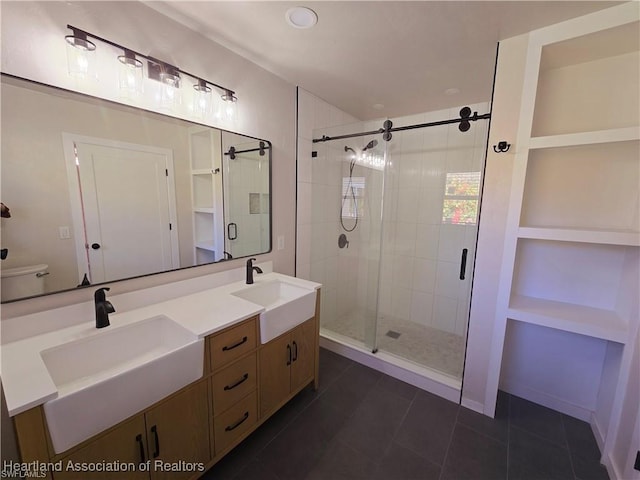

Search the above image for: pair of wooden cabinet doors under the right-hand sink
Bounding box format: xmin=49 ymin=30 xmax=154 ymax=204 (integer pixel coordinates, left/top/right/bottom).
xmin=259 ymin=318 xmax=317 ymax=418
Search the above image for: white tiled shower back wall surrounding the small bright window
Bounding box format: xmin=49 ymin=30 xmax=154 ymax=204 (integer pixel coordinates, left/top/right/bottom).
xmin=379 ymin=103 xmax=489 ymax=335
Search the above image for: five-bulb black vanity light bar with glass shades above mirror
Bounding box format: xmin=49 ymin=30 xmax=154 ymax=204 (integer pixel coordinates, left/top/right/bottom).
xmin=65 ymin=25 xmax=238 ymax=121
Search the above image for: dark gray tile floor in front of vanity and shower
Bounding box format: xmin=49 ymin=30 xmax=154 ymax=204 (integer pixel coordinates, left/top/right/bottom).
xmin=202 ymin=349 xmax=608 ymax=480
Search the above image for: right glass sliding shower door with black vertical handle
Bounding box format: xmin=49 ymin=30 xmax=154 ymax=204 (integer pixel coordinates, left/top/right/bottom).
xmin=377 ymin=109 xmax=487 ymax=379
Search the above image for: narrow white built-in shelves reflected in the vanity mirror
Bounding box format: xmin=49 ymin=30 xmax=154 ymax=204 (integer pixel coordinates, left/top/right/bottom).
xmin=189 ymin=127 xmax=224 ymax=265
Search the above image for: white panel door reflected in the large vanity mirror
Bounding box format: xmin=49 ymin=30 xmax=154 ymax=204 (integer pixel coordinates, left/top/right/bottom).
xmin=64 ymin=137 xmax=179 ymax=283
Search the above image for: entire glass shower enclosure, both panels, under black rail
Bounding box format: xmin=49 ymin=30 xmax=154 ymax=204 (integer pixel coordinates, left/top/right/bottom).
xmin=308 ymin=104 xmax=488 ymax=382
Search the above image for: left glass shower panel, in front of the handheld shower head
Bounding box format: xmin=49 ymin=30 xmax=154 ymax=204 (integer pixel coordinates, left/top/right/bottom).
xmin=310 ymin=123 xmax=385 ymax=351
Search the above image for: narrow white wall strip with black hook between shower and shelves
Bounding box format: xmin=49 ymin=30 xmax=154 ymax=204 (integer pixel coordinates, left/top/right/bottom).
xmin=462 ymin=34 xmax=528 ymax=412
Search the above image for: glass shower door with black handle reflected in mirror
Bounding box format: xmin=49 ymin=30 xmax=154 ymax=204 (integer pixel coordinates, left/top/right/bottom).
xmin=223 ymin=139 xmax=271 ymax=257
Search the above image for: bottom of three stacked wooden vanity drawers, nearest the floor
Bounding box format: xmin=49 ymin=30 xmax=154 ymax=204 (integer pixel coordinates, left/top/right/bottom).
xmin=213 ymin=391 xmax=258 ymax=452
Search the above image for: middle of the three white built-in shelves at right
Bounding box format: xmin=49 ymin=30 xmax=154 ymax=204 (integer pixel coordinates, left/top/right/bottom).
xmin=518 ymin=227 xmax=640 ymax=247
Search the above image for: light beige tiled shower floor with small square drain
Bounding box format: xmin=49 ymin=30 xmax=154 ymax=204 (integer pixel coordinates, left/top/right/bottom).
xmin=322 ymin=312 xmax=465 ymax=379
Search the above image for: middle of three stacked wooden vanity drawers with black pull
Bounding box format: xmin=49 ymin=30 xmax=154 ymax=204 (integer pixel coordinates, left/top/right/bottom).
xmin=213 ymin=353 xmax=257 ymax=415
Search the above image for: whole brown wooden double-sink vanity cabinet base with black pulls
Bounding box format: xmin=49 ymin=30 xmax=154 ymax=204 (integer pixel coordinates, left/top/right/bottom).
xmin=14 ymin=291 xmax=320 ymax=480
